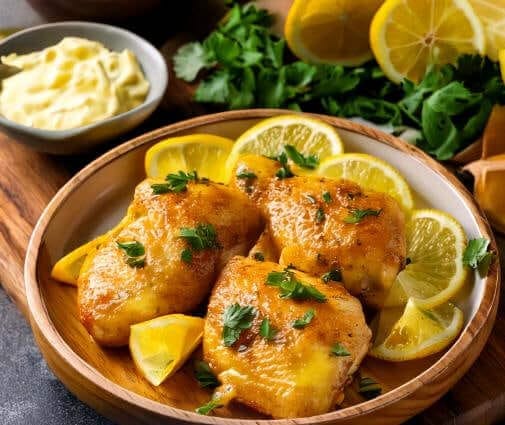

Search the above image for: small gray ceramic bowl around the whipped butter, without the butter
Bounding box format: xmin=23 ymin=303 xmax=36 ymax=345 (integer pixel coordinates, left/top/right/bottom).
xmin=0 ymin=21 xmax=168 ymax=155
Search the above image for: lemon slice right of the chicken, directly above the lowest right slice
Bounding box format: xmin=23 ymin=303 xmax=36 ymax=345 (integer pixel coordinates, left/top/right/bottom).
xmin=385 ymin=209 xmax=467 ymax=308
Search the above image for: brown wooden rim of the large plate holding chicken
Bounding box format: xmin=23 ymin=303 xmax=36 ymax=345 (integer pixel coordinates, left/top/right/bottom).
xmin=24 ymin=109 xmax=500 ymax=425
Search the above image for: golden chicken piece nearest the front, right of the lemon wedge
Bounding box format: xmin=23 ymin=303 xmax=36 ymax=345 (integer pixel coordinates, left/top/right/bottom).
xmin=203 ymin=256 xmax=371 ymax=418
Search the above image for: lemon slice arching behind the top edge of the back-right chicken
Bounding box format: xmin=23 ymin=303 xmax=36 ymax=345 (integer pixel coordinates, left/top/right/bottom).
xmin=317 ymin=153 xmax=414 ymax=210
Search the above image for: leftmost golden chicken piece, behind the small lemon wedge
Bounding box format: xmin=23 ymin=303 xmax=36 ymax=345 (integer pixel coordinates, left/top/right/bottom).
xmin=78 ymin=180 xmax=262 ymax=346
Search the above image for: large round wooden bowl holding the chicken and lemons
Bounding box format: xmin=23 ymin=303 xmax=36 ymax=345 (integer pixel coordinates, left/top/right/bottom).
xmin=25 ymin=110 xmax=500 ymax=425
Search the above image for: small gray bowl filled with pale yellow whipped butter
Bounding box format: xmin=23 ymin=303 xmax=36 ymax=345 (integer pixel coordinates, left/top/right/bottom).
xmin=0 ymin=22 xmax=168 ymax=154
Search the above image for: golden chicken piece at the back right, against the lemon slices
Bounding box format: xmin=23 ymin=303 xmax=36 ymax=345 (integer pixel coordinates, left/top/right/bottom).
xmin=231 ymin=155 xmax=406 ymax=308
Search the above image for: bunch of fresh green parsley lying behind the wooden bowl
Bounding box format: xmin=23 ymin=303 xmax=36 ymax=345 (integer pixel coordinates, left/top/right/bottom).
xmin=173 ymin=4 xmax=505 ymax=160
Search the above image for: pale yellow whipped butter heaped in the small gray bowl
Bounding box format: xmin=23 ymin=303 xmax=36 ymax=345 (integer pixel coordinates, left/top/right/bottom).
xmin=0 ymin=37 xmax=149 ymax=130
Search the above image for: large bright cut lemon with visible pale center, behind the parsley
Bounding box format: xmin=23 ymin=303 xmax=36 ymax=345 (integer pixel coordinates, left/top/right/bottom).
xmin=370 ymin=0 xmax=486 ymax=83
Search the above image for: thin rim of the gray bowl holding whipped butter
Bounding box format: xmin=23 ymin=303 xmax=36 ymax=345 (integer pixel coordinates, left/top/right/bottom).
xmin=0 ymin=21 xmax=168 ymax=141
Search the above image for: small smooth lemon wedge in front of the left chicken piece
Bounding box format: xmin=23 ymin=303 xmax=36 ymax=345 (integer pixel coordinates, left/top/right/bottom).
xmin=130 ymin=314 xmax=205 ymax=386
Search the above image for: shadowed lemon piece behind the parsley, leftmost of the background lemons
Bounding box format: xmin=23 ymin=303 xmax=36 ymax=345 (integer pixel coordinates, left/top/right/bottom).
xmin=284 ymin=0 xmax=383 ymax=65
